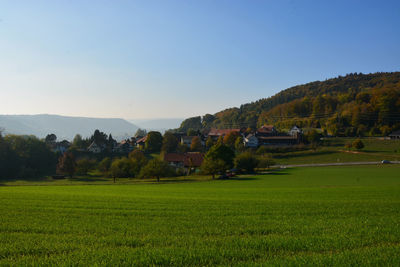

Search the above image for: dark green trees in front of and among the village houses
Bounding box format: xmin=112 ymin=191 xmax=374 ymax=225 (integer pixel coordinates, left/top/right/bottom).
xmin=0 ymin=125 xmax=363 ymax=180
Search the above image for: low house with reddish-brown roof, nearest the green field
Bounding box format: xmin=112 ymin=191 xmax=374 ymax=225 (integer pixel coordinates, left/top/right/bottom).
xmin=164 ymin=152 xmax=204 ymax=168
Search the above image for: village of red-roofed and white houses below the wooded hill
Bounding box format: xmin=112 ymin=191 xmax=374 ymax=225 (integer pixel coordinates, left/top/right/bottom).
xmin=42 ymin=125 xmax=303 ymax=173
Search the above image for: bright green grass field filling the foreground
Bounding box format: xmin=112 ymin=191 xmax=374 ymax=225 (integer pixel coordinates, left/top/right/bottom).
xmin=0 ymin=165 xmax=400 ymax=266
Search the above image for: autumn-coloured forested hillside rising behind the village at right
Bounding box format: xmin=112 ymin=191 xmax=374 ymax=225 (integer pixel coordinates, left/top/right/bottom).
xmin=179 ymin=72 xmax=400 ymax=136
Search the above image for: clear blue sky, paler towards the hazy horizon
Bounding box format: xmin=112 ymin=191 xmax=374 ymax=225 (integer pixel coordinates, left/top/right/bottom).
xmin=0 ymin=0 xmax=400 ymax=118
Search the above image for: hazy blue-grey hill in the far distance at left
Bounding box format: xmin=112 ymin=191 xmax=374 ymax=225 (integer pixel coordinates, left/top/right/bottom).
xmin=0 ymin=114 xmax=138 ymax=140
